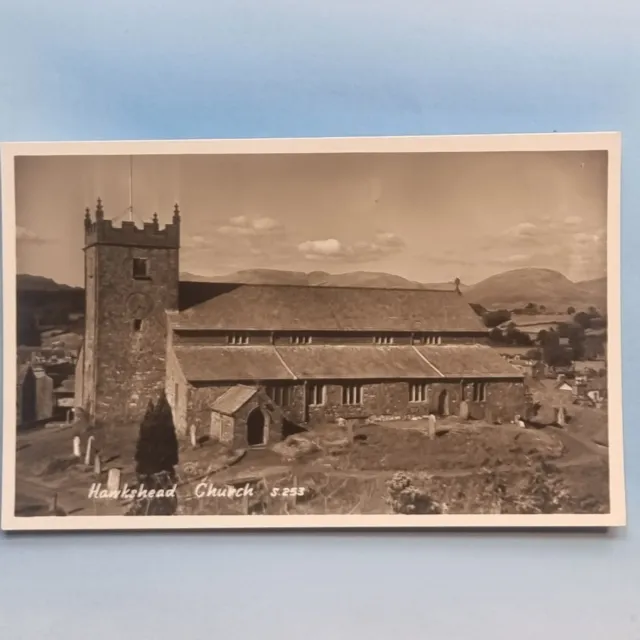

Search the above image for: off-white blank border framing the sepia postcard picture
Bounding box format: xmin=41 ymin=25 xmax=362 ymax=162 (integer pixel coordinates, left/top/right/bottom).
xmin=0 ymin=133 xmax=626 ymax=531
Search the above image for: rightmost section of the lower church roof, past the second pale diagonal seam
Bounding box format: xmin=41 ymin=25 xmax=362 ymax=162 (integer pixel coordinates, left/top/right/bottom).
xmin=416 ymin=344 xmax=523 ymax=378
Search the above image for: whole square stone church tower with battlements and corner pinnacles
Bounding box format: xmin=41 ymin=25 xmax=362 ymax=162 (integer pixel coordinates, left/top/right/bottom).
xmin=76 ymin=200 xmax=180 ymax=424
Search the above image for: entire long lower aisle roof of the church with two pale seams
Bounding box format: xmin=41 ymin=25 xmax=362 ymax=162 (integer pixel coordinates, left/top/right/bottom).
xmin=174 ymin=345 xmax=524 ymax=382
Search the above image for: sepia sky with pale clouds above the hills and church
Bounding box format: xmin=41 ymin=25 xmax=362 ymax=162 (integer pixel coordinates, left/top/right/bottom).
xmin=16 ymin=151 xmax=607 ymax=285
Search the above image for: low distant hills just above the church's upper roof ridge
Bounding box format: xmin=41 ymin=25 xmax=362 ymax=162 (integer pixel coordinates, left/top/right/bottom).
xmin=180 ymin=269 xmax=464 ymax=290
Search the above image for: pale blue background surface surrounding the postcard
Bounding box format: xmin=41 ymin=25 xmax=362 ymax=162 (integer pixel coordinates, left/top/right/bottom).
xmin=0 ymin=0 xmax=640 ymax=640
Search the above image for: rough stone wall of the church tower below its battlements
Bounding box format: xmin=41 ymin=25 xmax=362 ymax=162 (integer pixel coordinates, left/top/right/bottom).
xmin=84 ymin=245 xmax=178 ymax=422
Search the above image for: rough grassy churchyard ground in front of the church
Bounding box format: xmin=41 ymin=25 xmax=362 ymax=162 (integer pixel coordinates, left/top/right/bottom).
xmin=16 ymin=412 xmax=609 ymax=516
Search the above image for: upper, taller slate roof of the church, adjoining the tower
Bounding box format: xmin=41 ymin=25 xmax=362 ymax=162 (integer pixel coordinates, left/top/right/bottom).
xmin=172 ymin=282 xmax=487 ymax=333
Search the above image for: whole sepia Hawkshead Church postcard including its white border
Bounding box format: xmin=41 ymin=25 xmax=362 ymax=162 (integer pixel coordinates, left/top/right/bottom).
xmin=2 ymin=133 xmax=626 ymax=530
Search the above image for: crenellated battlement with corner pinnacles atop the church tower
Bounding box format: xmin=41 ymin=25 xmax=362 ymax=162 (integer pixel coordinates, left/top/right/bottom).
xmin=84 ymin=199 xmax=180 ymax=249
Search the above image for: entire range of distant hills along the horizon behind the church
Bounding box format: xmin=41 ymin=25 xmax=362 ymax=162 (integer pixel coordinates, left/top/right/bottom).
xmin=17 ymin=268 xmax=607 ymax=312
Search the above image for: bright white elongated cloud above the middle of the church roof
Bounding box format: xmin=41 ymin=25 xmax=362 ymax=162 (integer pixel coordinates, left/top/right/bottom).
xmin=298 ymin=232 xmax=405 ymax=262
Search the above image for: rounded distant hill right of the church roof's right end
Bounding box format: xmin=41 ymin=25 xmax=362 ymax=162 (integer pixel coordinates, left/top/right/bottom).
xmin=465 ymin=268 xmax=606 ymax=311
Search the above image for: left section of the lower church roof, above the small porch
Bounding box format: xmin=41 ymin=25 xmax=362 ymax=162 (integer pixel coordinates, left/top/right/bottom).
xmin=174 ymin=346 xmax=293 ymax=382
